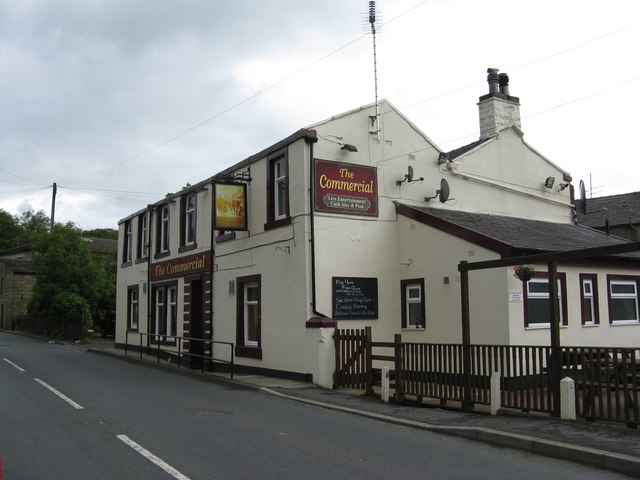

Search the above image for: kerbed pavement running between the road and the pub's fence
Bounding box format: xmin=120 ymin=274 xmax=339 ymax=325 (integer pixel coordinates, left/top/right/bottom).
xmin=76 ymin=345 xmax=640 ymax=478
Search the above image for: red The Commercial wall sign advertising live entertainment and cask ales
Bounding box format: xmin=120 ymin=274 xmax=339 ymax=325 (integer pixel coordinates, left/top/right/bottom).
xmin=315 ymin=160 xmax=378 ymax=216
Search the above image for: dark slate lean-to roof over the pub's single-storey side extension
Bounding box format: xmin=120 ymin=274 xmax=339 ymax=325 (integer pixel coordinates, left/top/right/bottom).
xmin=400 ymin=205 xmax=640 ymax=261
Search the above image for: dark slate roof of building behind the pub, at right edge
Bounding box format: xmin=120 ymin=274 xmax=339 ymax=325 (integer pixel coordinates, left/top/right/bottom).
xmin=578 ymin=192 xmax=640 ymax=228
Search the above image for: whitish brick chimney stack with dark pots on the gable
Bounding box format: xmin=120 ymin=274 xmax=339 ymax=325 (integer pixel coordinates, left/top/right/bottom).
xmin=478 ymin=68 xmax=520 ymax=140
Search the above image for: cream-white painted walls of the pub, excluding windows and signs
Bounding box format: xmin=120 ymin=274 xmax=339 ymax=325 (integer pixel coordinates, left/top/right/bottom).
xmin=116 ymin=75 xmax=640 ymax=384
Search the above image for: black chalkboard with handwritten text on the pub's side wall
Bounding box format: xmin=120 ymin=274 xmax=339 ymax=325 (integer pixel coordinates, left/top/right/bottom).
xmin=332 ymin=277 xmax=378 ymax=320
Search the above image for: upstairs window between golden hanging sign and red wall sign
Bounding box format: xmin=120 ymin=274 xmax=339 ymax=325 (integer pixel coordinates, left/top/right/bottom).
xmin=264 ymin=151 xmax=291 ymax=230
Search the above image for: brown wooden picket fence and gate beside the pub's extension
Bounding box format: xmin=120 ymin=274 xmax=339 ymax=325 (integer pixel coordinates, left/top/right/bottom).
xmin=334 ymin=327 xmax=640 ymax=427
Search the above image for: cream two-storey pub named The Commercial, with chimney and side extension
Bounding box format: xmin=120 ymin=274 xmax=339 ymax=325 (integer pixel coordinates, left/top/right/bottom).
xmin=116 ymin=69 xmax=640 ymax=387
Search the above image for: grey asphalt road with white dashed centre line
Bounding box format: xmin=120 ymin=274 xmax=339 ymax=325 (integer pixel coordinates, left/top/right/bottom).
xmin=0 ymin=332 xmax=627 ymax=480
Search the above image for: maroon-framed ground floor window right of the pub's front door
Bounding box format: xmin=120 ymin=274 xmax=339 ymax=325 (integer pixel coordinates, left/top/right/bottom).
xmin=236 ymin=275 xmax=262 ymax=358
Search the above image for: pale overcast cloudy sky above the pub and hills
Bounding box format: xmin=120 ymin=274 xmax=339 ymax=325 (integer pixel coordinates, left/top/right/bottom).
xmin=0 ymin=0 xmax=640 ymax=229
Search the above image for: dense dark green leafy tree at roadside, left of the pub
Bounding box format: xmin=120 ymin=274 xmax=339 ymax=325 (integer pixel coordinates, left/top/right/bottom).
xmin=29 ymin=223 xmax=100 ymax=338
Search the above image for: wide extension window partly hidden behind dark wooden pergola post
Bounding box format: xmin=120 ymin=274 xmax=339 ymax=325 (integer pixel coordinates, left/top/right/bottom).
xmin=524 ymin=273 xmax=567 ymax=328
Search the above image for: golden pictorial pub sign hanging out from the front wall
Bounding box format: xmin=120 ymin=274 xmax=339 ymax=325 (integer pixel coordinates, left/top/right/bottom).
xmin=213 ymin=183 xmax=247 ymax=230
